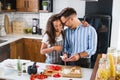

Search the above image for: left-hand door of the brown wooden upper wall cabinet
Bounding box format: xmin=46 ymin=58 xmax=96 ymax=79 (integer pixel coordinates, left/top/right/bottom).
xmin=16 ymin=0 xmax=27 ymax=12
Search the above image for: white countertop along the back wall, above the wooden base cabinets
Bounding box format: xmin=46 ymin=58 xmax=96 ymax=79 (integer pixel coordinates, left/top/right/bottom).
xmin=0 ymin=34 xmax=42 ymax=47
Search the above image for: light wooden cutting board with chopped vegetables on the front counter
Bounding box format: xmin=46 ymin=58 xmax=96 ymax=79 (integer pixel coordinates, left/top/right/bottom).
xmin=44 ymin=65 xmax=82 ymax=78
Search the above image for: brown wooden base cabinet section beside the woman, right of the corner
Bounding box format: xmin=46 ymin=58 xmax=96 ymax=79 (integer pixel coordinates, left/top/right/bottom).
xmin=24 ymin=38 xmax=46 ymax=62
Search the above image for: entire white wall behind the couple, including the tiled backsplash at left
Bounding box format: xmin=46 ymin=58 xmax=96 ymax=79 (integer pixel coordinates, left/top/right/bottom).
xmin=0 ymin=0 xmax=85 ymax=30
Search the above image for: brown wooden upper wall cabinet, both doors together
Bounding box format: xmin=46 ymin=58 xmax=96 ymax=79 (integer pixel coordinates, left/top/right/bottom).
xmin=16 ymin=0 xmax=39 ymax=12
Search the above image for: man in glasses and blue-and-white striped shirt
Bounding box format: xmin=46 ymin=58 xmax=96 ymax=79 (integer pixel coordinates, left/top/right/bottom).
xmin=59 ymin=7 xmax=97 ymax=67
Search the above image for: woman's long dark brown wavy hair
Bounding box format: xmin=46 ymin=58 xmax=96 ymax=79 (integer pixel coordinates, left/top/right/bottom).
xmin=45 ymin=14 xmax=63 ymax=46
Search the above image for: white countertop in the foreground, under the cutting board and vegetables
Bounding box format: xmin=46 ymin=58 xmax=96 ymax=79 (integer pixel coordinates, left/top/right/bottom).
xmin=0 ymin=59 xmax=93 ymax=80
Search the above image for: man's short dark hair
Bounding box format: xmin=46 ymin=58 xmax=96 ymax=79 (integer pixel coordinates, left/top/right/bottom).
xmin=59 ymin=7 xmax=77 ymax=17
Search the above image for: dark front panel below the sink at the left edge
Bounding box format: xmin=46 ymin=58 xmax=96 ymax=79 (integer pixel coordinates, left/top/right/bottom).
xmin=0 ymin=44 xmax=10 ymax=62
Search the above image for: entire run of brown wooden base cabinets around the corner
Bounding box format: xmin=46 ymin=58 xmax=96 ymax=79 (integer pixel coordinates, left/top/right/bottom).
xmin=10 ymin=38 xmax=46 ymax=62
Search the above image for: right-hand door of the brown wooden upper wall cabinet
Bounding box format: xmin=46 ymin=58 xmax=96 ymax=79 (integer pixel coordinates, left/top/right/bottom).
xmin=26 ymin=0 xmax=39 ymax=12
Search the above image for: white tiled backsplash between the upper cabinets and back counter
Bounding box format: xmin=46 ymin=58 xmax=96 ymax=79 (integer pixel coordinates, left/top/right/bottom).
xmin=0 ymin=12 xmax=53 ymax=30
